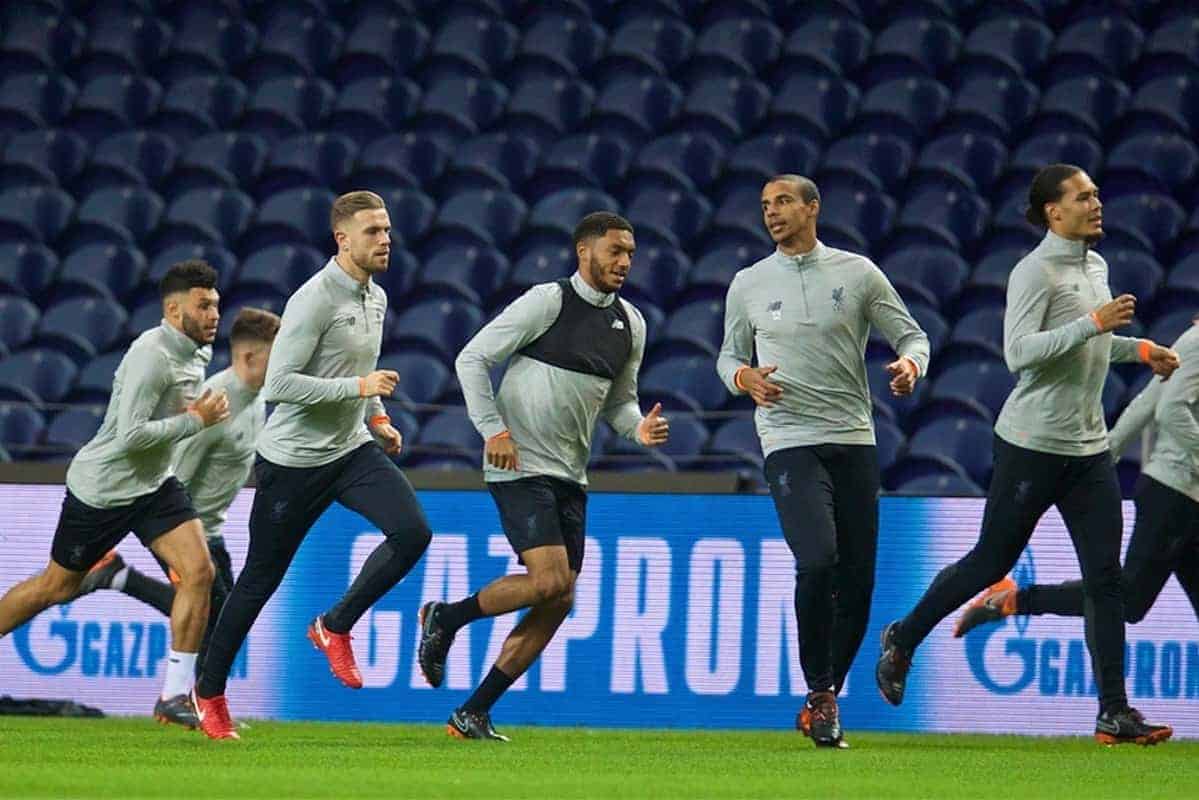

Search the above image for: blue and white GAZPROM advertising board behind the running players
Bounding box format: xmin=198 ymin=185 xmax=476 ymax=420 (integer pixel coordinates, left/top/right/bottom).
xmin=0 ymin=485 xmax=1199 ymax=736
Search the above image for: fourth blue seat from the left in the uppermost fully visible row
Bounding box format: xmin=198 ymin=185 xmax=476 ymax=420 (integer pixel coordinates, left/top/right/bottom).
xmin=241 ymin=17 xmax=345 ymax=84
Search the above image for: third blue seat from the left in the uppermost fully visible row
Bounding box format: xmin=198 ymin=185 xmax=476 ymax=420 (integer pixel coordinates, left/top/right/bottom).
xmin=156 ymin=13 xmax=259 ymax=80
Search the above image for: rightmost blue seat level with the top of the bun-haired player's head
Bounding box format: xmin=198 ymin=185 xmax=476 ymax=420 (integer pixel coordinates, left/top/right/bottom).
xmin=1102 ymin=133 xmax=1199 ymax=197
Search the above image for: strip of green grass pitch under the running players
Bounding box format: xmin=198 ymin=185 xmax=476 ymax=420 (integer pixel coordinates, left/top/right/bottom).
xmin=0 ymin=717 xmax=1199 ymax=800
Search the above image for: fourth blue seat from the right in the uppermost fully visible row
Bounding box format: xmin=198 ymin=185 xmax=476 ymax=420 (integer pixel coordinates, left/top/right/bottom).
xmin=862 ymin=17 xmax=962 ymax=85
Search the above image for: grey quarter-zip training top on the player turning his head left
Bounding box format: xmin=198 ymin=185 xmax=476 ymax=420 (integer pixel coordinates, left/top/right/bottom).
xmin=716 ymin=241 xmax=928 ymax=456
